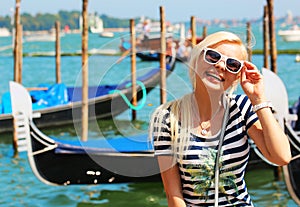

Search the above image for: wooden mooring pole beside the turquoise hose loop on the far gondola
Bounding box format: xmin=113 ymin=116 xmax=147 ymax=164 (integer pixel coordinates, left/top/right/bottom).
xmin=130 ymin=19 xmax=137 ymax=120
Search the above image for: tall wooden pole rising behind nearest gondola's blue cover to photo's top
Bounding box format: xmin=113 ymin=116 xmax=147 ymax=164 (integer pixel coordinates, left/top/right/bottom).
xmin=81 ymin=0 xmax=89 ymax=141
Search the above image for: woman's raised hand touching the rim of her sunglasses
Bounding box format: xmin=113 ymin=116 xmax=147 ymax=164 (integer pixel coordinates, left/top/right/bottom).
xmin=241 ymin=61 xmax=266 ymax=105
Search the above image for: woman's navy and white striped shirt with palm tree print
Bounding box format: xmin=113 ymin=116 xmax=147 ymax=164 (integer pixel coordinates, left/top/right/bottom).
xmin=153 ymin=95 xmax=258 ymax=206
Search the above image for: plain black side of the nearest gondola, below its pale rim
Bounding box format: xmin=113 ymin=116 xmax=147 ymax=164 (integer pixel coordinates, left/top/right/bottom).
xmin=34 ymin=151 xmax=160 ymax=185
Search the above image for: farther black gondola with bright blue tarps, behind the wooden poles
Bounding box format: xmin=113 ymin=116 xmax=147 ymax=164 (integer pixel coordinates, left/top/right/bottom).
xmin=0 ymin=57 xmax=176 ymax=133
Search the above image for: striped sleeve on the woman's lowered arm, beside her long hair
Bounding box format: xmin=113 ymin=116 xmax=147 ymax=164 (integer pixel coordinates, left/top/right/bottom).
xmin=151 ymin=106 xmax=173 ymax=155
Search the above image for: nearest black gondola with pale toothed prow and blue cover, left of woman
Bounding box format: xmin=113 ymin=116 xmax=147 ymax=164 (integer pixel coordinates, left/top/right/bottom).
xmin=10 ymin=82 xmax=161 ymax=185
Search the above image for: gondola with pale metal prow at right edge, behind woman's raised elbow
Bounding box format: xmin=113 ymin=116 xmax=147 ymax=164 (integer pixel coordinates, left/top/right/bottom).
xmin=263 ymin=69 xmax=300 ymax=205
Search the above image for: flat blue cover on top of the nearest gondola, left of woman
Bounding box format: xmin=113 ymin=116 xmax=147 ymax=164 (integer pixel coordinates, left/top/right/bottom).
xmin=52 ymin=134 xmax=153 ymax=154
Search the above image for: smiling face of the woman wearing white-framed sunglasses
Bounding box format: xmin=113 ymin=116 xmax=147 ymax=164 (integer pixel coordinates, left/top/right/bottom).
xmin=196 ymin=43 xmax=244 ymax=91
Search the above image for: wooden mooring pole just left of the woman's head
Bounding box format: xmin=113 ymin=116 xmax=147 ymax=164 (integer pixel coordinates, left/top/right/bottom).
xmin=160 ymin=6 xmax=167 ymax=104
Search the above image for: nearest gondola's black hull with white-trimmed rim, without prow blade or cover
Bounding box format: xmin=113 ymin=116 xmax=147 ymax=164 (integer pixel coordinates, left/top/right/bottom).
xmin=28 ymin=123 xmax=161 ymax=185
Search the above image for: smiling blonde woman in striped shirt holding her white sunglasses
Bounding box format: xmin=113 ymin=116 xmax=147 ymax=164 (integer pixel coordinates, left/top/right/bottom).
xmin=150 ymin=32 xmax=291 ymax=207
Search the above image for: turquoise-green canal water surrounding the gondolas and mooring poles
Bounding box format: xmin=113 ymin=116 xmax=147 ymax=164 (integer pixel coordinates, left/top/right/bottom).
xmin=0 ymin=25 xmax=300 ymax=207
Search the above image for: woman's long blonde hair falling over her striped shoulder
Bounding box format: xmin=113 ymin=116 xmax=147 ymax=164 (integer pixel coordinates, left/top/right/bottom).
xmin=149 ymin=31 xmax=247 ymax=160
